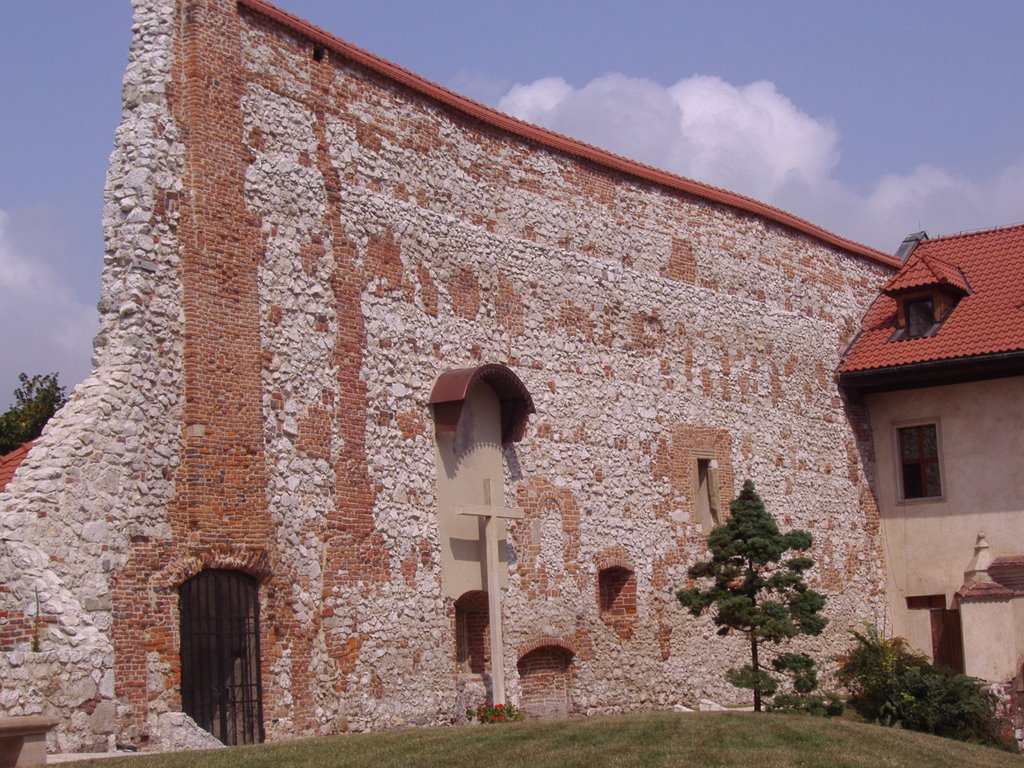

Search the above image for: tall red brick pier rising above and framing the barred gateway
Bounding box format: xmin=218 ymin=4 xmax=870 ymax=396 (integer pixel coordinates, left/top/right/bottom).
xmin=112 ymin=0 xmax=312 ymax=743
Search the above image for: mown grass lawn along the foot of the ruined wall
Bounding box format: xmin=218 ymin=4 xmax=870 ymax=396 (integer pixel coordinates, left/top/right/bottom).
xmin=70 ymin=713 xmax=1024 ymax=768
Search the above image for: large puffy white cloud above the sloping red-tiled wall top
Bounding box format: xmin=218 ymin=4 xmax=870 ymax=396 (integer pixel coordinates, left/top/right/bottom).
xmin=498 ymin=74 xmax=1024 ymax=252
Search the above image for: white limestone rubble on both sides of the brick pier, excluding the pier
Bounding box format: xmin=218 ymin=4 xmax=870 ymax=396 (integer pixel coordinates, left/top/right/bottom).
xmin=0 ymin=0 xmax=886 ymax=751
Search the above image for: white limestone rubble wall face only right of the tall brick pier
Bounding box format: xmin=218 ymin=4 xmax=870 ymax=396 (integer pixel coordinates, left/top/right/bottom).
xmin=237 ymin=15 xmax=887 ymax=729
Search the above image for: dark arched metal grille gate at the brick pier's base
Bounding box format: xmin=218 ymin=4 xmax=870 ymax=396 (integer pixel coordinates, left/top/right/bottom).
xmin=179 ymin=570 xmax=263 ymax=745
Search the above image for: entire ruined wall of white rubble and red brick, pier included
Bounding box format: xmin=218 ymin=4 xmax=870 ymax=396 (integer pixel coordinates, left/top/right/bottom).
xmin=0 ymin=0 xmax=891 ymax=752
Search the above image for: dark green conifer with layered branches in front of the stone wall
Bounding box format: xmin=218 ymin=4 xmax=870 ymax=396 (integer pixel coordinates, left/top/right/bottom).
xmin=676 ymin=480 xmax=827 ymax=712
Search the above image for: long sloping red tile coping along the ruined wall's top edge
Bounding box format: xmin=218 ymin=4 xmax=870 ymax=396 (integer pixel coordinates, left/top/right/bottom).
xmin=239 ymin=0 xmax=899 ymax=266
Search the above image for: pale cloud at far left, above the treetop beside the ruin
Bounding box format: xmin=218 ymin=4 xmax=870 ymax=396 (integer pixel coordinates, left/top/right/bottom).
xmin=0 ymin=210 xmax=97 ymax=411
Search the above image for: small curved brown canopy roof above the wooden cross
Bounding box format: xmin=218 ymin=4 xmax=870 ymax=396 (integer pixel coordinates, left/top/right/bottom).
xmin=430 ymin=364 xmax=537 ymax=445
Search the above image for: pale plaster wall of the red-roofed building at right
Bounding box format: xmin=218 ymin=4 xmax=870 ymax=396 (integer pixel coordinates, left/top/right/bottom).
xmin=866 ymin=377 xmax=1024 ymax=655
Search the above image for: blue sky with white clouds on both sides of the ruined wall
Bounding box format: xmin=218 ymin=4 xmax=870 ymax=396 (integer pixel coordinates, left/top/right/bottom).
xmin=0 ymin=0 xmax=1024 ymax=408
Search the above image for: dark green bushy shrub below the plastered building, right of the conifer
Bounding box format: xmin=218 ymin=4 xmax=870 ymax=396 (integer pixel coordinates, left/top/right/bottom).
xmin=837 ymin=626 xmax=1009 ymax=748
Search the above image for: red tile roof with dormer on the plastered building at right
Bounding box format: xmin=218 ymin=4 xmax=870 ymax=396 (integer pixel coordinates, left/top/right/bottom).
xmin=839 ymin=225 xmax=1024 ymax=373
